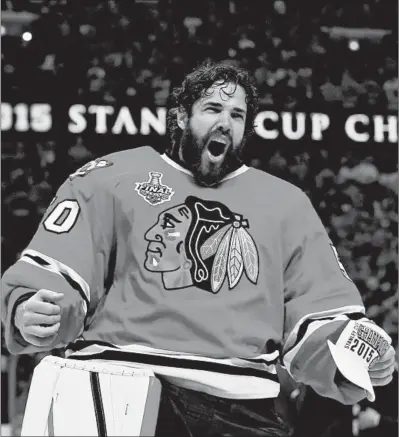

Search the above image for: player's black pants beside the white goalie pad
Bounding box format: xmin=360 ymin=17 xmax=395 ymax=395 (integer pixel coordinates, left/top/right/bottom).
xmin=155 ymin=380 xmax=290 ymax=437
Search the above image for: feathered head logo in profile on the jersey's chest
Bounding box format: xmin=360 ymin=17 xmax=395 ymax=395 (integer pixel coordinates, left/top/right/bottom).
xmin=144 ymin=196 xmax=259 ymax=294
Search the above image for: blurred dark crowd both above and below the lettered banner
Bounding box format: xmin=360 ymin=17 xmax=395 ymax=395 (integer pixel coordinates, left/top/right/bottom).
xmin=1 ymin=0 xmax=398 ymax=435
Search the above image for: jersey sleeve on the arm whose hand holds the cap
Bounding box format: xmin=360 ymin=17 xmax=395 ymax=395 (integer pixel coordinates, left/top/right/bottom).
xmin=282 ymin=193 xmax=366 ymax=404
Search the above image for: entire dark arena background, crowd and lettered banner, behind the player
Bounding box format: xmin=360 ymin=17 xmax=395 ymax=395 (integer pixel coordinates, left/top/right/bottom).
xmin=1 ymin=0 xmax=398 ymax=437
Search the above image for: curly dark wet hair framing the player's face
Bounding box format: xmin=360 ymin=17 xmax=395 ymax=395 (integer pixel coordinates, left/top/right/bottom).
xmin=166 ymin=61 xmax=259 ymax=149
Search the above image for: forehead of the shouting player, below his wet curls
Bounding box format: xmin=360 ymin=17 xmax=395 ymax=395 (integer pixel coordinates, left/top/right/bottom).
xmin=197 ymin=82 xmax=247 ymax=109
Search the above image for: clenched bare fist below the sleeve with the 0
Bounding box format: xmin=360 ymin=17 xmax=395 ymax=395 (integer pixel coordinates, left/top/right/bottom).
xmin=14 ymin=289 xmax=64 ymax=346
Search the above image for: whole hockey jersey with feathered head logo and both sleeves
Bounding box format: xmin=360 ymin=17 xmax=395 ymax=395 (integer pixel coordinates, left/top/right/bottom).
xmin=2 ymin=147 xmax=364 ymax=403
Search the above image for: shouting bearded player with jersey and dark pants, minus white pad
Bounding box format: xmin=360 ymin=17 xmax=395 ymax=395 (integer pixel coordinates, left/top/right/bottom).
xmin=2 ymin=60 xmax=394 ymax=436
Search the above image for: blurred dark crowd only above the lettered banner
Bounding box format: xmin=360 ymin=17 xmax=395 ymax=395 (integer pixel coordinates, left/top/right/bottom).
xmin=2 ymin=0 xmax=398 ymax=111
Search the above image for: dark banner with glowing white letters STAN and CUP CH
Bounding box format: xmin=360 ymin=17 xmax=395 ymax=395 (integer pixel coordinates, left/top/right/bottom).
xmin=1 ymin=102 xmax=398 ymax=144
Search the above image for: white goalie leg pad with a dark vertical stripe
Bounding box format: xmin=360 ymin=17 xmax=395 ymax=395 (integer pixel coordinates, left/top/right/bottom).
xmin=21 ymin=356 xmax=161 ymax=436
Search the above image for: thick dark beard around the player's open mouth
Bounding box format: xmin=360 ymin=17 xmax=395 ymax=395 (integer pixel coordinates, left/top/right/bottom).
xmin=178 ymin=126 xmax=244 ymax=187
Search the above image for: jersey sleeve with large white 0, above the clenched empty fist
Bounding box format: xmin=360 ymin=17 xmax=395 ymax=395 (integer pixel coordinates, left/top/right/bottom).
xmin=1 ymin=170 xmax=113 ymax=354
